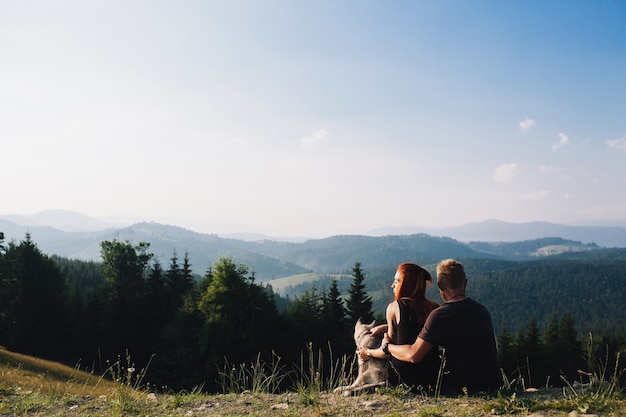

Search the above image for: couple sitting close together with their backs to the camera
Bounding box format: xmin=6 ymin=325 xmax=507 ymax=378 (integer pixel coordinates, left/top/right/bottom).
xmin=357 ymin=259 xmax=502 ymax=395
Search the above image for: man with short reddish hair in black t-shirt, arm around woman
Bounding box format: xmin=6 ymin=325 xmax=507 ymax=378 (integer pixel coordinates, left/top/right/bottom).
xmin=358 ymin=259 xmax=502 ymax=395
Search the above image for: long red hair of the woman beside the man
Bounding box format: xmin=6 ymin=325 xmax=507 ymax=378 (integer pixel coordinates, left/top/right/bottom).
xmin=395 ymin=262 xmax=439 ymax=326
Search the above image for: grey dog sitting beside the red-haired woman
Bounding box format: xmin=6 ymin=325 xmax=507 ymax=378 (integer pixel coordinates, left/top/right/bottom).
xmin=333 ymin=319 xmax=389 ymax=396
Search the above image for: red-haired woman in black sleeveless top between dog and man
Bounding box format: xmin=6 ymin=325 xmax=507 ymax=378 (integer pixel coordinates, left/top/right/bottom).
xmin=360 ymin=262 xmax=440 ymax=390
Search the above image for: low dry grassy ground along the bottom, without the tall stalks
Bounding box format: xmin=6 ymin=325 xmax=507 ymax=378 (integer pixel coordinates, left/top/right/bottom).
xmin=0 ymin=349 xmax=626 ymax=417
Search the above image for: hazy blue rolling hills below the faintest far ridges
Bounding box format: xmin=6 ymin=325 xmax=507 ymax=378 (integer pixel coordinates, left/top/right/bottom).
xmin=0 ymin=219 xmax=600 ymax=282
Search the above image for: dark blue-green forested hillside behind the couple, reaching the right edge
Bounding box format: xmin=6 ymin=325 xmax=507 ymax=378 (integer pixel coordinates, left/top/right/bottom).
xmin=268 ymin=249 xmax=626 ymax=335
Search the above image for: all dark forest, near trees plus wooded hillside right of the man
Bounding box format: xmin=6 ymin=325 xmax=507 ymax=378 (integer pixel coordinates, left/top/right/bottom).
xmin=0 ymin=233 xmax=626 ymax=392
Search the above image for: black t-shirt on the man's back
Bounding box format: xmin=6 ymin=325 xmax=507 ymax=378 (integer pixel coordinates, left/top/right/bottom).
xmin=419 ymin=298 xmax=502 ymax=394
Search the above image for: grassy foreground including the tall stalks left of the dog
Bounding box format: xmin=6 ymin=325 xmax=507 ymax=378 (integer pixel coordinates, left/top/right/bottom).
xmin=0 ymin=349 xmax=626 ymax=417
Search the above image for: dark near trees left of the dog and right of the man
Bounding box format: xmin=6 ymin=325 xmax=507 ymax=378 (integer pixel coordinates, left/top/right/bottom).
xmin=0 ymin=233 xmax=626 ymax=391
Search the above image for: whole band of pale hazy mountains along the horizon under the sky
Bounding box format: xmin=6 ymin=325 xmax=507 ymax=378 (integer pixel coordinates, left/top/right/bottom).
xmin=0 ymin=211 xmax=626 ymax=281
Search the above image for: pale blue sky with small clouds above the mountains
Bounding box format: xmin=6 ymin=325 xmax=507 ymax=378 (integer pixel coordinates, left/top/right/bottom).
xmin=0 ymin=0 xmax=626 ymax=237
